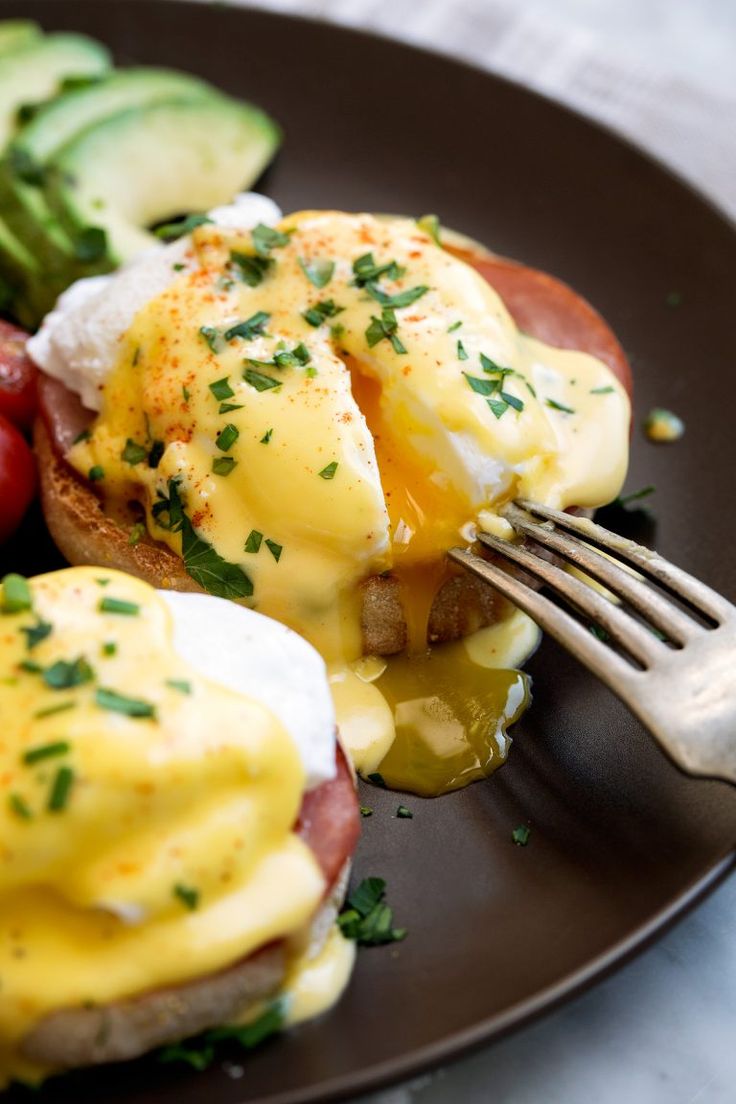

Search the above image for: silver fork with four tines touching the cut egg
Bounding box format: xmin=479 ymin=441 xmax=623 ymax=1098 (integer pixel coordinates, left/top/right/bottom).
xmin=449 ymin=500 xmax=736 ymax=783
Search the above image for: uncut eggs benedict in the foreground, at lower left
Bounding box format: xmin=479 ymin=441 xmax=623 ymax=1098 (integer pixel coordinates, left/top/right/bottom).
xmin=0 ymin=567 xmax=358 ymax=1084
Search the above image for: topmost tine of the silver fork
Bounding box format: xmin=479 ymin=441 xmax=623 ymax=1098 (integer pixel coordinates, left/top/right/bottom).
xmin=516 ymin=498 xmax=734 ymax=625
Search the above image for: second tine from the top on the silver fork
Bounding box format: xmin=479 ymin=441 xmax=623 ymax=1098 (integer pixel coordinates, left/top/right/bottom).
xmin=503 ymin=505 xmax=703 ymax=645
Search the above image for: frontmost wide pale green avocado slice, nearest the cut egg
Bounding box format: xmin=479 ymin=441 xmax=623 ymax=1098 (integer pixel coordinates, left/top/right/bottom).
xmin=47 ymin=94 xmax=280 ymax=263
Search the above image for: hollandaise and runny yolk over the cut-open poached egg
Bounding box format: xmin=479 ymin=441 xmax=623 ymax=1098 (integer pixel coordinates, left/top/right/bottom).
xmin=70 ymin=211 xmax=629 ymax=793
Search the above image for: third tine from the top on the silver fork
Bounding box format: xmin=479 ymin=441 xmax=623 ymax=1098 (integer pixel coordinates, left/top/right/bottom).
xmin=478 ymin=533 xmax=665 ymax=668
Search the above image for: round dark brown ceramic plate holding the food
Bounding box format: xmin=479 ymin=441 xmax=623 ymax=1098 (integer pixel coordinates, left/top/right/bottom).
xmin=0 ymin=0 xmax=736 ymax=1104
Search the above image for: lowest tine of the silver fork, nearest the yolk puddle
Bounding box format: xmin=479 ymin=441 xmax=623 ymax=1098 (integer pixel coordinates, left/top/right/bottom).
xmin=447 ymin=542 xmax=641 ymax=692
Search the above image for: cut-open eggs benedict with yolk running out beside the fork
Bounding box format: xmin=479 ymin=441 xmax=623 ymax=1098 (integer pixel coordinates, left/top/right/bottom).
xmin=29 ymin=198 xmax=630 ymax=793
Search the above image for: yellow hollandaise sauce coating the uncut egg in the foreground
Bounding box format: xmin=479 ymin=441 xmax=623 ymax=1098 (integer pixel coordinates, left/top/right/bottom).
xmin=0 ymin=567 xmax=328 ymax=1084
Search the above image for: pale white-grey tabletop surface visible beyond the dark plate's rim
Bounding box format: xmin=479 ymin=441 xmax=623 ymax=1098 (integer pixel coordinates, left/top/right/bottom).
xmin=194 ymin=0 xmax=736 ymax=1104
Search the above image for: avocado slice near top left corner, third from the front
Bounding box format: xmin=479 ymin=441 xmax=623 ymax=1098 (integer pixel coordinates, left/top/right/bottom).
xmin=0 ymin=34 xmax=110 ymax=147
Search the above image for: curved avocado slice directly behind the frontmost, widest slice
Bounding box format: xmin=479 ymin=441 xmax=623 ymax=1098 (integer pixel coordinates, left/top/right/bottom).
xmin=0 ymin=68 xmax=215 ymax=268
